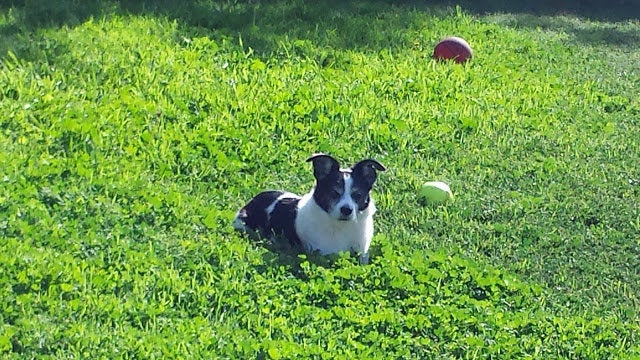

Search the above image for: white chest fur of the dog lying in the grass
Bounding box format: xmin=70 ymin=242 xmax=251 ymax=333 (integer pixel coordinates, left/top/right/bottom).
xmin=295 ymin=193 xmax=376 ymax=255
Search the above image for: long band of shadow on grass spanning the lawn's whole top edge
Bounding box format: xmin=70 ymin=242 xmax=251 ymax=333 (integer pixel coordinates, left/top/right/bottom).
xmin=0 ymin=0 xmax=640 ymax=60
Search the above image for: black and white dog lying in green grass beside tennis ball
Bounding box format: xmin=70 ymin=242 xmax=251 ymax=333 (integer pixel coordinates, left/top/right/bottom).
xmin=233 ymin=154 xmax=386 ymax=263
